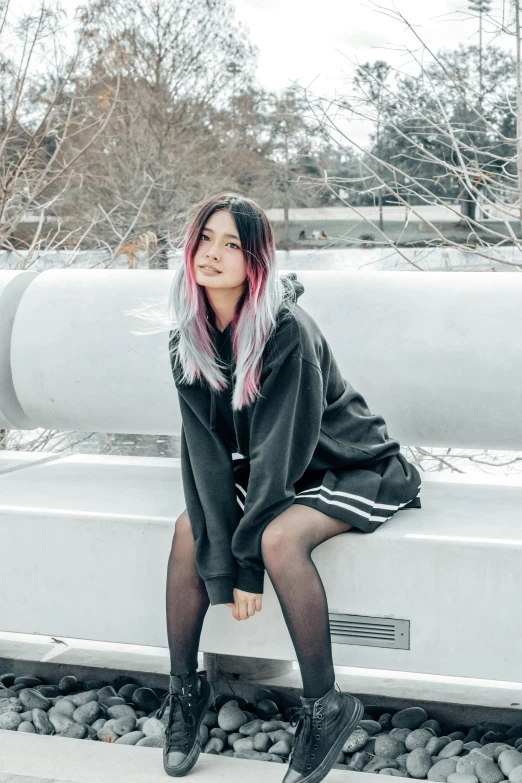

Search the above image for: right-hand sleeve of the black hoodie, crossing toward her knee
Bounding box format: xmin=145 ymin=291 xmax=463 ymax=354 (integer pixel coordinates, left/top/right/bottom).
xmin=232 ymin=353 xmax=323 ymax=593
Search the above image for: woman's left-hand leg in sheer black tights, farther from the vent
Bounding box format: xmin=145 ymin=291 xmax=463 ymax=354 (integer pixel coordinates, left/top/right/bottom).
xmin=167 ymin=510 xmax=210 ymax=674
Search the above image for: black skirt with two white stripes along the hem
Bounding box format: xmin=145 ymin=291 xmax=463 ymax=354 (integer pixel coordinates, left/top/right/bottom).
xmin=233 ymin=452 xmax=421 ymax=533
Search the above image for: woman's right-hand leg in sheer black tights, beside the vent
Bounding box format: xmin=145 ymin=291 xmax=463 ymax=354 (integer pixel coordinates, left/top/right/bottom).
xmin=261 ymin=503 xmax=352 ymax=698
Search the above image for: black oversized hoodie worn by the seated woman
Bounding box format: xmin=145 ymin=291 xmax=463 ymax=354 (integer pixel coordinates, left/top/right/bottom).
xmin=170 ymin=273 xmax=416 ymax=605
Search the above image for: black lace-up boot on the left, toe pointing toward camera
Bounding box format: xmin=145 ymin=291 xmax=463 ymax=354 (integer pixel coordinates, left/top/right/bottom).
xmin=156 ymin=669 xmax=214 ymax=777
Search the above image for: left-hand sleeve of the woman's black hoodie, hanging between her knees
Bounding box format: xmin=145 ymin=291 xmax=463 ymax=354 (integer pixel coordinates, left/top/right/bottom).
xmin=178 ymin=396 xmax=238 ymax=606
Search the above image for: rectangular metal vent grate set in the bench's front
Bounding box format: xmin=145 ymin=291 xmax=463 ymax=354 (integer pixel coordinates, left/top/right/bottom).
xmin=328 ymin=612 xmax=410 ymax=650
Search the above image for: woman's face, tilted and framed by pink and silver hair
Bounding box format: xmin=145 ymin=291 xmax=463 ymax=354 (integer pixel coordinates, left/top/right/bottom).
xmin=194 ymin=209 xmax=247 ymax=288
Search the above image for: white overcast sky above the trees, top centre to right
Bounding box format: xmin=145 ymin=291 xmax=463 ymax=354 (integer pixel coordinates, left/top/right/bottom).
xmin=233 ymin=0 xmax=508 ymax=95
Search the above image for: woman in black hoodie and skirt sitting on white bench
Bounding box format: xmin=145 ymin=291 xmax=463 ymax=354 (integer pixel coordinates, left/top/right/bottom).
xmin=158 ymin=193 xmax=420 ymax=783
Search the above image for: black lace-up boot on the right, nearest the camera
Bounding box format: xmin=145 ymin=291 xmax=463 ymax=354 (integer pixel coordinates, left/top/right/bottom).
xmin=283 ymin=683 xmax=364 ymax=783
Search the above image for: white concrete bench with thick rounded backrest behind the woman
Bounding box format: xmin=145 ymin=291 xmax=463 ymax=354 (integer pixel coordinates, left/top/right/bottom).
xmin=0 ymin=270 xmax=522 ymax=707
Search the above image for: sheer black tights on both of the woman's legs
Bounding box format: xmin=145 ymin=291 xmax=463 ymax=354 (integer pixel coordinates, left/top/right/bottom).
xmin=167 ymin=516 xmax=340 ymax=698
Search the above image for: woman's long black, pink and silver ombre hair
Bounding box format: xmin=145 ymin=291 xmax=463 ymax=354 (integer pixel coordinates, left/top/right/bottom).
xmin=168 ymin=193 xmax=295 ymax=410
